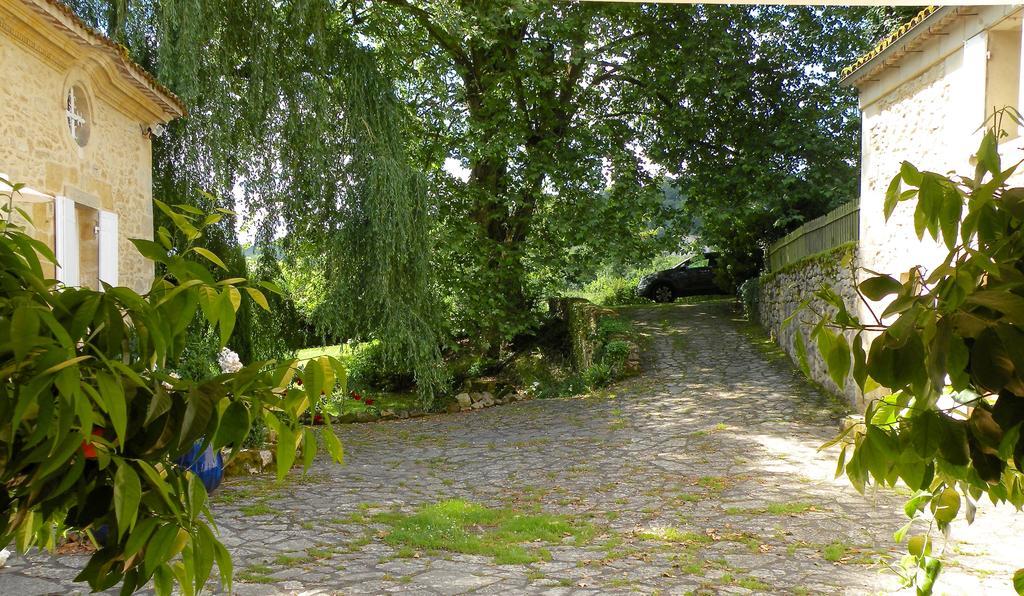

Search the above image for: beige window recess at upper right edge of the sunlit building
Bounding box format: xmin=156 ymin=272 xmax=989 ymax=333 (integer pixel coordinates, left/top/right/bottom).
xmin=985 ymin=12 xmax=1021 ymax=138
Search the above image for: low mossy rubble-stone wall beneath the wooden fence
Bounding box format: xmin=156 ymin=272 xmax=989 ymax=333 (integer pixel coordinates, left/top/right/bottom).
xmin=758 ymin=243 xmax=863 ymax=410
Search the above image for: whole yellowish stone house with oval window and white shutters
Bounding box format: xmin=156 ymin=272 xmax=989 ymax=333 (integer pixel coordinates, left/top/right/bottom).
xmin=0 ymin=0 xmax=185 ymax=292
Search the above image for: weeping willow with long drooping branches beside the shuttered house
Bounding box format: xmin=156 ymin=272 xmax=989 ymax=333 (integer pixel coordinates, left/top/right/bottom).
xmin=72 ymin=0 xmax=443 ymax=400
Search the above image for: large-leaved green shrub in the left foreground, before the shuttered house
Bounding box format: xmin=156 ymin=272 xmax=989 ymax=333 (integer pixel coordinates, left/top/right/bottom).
xmin=0 ymin=184 xmax=344 ymax=594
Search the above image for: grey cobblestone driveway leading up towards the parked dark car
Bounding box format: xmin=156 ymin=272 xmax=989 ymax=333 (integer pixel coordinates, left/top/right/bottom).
xmin=0 ymin=303 xmax=1024 ymax=594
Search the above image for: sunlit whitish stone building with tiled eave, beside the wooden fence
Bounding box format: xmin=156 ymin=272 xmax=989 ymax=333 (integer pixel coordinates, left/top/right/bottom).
xmin=843 ymin=4 xmax=1024 ymax=316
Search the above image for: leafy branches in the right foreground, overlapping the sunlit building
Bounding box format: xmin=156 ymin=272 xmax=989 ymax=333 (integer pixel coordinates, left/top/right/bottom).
xmin=814 ymin=123 xmax=1024 ymax=592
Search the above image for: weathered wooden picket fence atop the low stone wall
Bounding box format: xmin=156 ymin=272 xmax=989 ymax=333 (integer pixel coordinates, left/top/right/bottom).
xmin=767 ymin=201 xmax=860 ymax=271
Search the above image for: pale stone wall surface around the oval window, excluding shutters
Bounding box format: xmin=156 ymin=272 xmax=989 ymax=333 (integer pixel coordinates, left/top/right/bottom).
xmin=0 ymin=5 xmax=163 ymax=292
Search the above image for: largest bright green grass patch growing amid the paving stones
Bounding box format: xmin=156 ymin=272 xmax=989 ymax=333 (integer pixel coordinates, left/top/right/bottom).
xmin=374 ymin=500 xmax=597 ymax=565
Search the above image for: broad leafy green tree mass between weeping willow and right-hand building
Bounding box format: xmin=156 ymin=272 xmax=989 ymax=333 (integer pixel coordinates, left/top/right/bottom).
xmin=359 ymin=0 xmax=870 ymax=348
